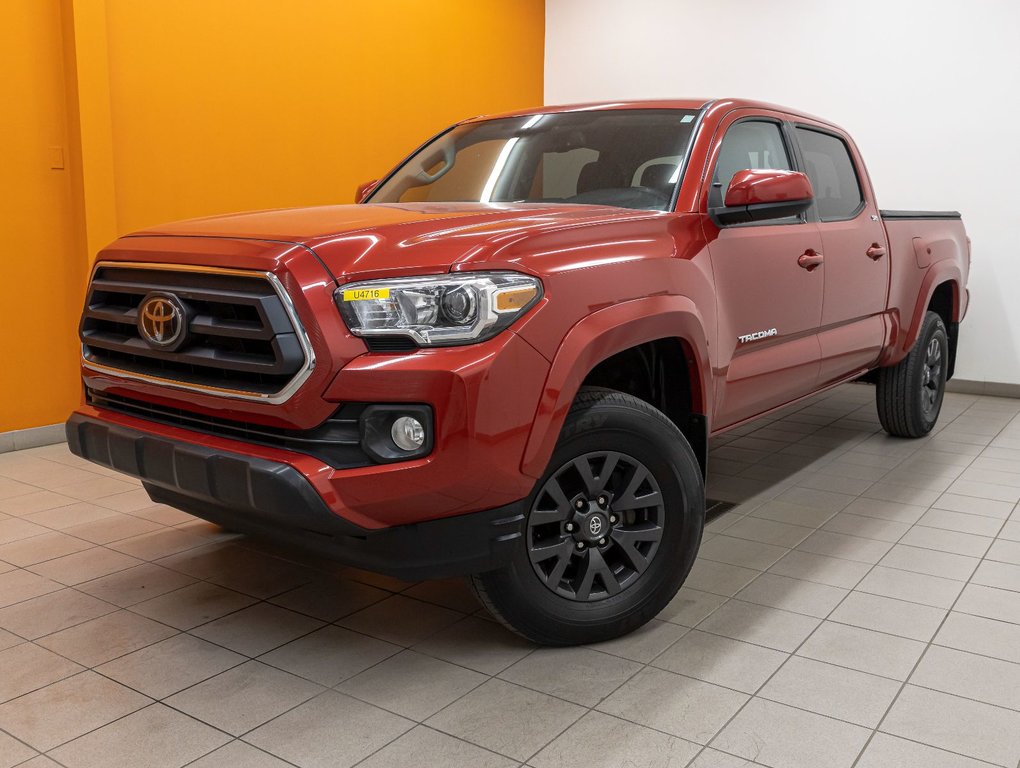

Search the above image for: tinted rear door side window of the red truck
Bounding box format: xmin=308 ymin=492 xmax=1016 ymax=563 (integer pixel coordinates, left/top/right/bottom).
xmin=797 ymin=127 xmax=864 ymax=221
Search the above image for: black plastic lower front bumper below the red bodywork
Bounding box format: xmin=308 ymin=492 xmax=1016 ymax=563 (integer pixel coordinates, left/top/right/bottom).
xmin=66 ymin=413 xmax=524 ymax=580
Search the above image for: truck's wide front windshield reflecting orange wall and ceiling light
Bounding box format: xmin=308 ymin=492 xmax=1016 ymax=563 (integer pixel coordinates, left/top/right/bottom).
xmin=366 ymin=109 xmax=698 ymax=211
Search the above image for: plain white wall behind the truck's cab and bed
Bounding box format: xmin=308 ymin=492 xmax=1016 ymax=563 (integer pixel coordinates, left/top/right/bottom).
xmin=546 ymin=0 xmax=1020 ymax=383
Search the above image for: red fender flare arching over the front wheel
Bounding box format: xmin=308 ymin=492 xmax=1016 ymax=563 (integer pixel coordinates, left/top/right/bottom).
xmin=521 ymin=295 xmax=711 ymax=477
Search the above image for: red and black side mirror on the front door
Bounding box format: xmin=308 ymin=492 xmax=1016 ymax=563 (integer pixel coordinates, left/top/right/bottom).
xmin=709 ymin=169 xmax=814 ymax=225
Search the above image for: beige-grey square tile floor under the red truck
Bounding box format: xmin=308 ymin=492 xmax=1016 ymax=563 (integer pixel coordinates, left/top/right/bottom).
xmin=0 ymin=386 xmax=1020 ymax=768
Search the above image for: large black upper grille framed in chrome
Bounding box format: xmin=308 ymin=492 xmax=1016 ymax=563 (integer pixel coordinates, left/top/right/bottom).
xmin=81 ymin=264 xmax=311 ymax=399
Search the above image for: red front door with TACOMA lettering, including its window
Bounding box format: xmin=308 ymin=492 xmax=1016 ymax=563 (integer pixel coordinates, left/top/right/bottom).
xmin=702 ymin=110 xmax=825 ymax=427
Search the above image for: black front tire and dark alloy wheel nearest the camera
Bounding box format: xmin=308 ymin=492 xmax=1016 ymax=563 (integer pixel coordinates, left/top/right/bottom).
xmin=470 ymin=388 xmax=705 ymax=646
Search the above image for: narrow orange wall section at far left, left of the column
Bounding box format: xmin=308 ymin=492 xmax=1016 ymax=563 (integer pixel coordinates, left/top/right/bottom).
xmin=0 ymin=0 xmax=86 ymax=431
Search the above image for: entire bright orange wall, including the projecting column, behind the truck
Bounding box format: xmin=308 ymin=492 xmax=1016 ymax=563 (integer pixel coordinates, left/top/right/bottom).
xmin=0 ymin=0 xmax=545 ymax=431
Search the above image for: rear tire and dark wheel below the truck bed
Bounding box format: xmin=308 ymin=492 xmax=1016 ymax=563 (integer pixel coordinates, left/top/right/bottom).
xmin=875 ymin=312 xmax=950 ymax=438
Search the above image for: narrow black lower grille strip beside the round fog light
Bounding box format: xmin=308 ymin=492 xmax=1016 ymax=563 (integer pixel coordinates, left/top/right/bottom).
xmin=86 ymin=389 xmax=376 ymax=469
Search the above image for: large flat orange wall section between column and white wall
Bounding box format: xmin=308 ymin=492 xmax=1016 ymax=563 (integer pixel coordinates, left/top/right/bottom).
xmin=106 ymin=0 xmax=545 ymax=232
